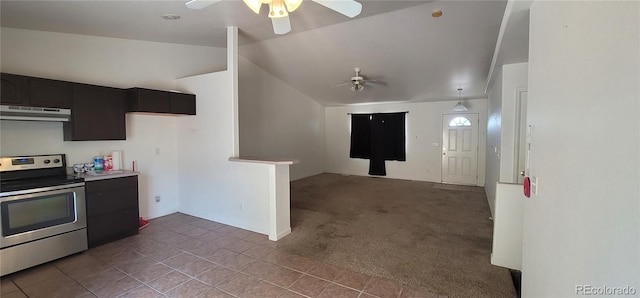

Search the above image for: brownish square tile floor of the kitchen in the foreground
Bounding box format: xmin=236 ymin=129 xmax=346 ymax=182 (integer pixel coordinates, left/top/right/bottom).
xmin=0 ymin=213 xmax=437 ymax=298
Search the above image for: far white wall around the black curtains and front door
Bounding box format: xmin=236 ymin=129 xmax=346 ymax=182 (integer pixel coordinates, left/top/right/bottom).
xmin=325 ymin=99 xmax=487 ymax=185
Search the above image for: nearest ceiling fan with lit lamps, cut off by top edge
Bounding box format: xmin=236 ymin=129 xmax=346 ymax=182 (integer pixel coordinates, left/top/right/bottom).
xmin=186 ymin=0 xmax=362 ymax=34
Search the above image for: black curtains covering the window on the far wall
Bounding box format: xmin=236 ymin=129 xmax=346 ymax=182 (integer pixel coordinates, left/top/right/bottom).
xmin=349 ymin=112 xmax=406 ymax=176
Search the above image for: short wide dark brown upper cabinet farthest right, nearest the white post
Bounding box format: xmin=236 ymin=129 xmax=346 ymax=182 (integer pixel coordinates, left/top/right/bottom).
xmin=127 ymin=88 xmax=196 ymax=115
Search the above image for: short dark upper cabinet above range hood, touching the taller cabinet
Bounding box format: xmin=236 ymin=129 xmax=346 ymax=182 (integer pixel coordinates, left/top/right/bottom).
xmin=29 ymin=78 xmax=72 ymax=109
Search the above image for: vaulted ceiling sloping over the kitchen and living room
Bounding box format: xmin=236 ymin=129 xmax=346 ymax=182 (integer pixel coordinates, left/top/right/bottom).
xmin=0 ymin=0 xmax=506 ymax=106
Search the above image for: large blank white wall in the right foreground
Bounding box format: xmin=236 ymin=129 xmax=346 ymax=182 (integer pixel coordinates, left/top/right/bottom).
xmin=522 ymin=1 xmax=640 ymax=297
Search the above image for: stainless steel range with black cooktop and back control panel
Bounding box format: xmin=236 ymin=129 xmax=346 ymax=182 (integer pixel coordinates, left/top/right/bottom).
xmin=0 ymin=154 xmax=87 ymax=275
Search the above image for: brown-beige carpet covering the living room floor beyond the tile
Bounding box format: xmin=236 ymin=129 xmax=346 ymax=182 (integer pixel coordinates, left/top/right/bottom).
xmin=277 ymin=174 xmax=516 ymax=297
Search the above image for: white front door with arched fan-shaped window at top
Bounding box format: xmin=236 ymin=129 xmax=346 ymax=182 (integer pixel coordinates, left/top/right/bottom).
xmin=442 ymin=114 xmax=479 ymax=185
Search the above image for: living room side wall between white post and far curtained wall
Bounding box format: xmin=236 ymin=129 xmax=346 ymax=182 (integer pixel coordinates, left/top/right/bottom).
xmin=239 ymin=58 xmax=325 ymax=180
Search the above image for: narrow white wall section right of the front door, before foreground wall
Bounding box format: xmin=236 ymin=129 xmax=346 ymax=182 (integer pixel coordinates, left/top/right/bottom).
xmin=485 ymin=62 xmax=527 ymax=214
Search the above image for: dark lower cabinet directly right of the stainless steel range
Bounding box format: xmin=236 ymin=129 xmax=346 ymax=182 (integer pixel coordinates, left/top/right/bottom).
xmin=85 ymin=176 xmax=139 ymax=248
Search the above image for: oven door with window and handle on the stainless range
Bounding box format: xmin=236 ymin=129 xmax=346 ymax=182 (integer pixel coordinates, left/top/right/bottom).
xmin=0 ymin=183 xmax=87 ymax=248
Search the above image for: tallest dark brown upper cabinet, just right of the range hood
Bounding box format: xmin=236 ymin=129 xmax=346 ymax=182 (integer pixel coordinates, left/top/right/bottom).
xmin=63 ymin=84 xmax=127 ymax=141
